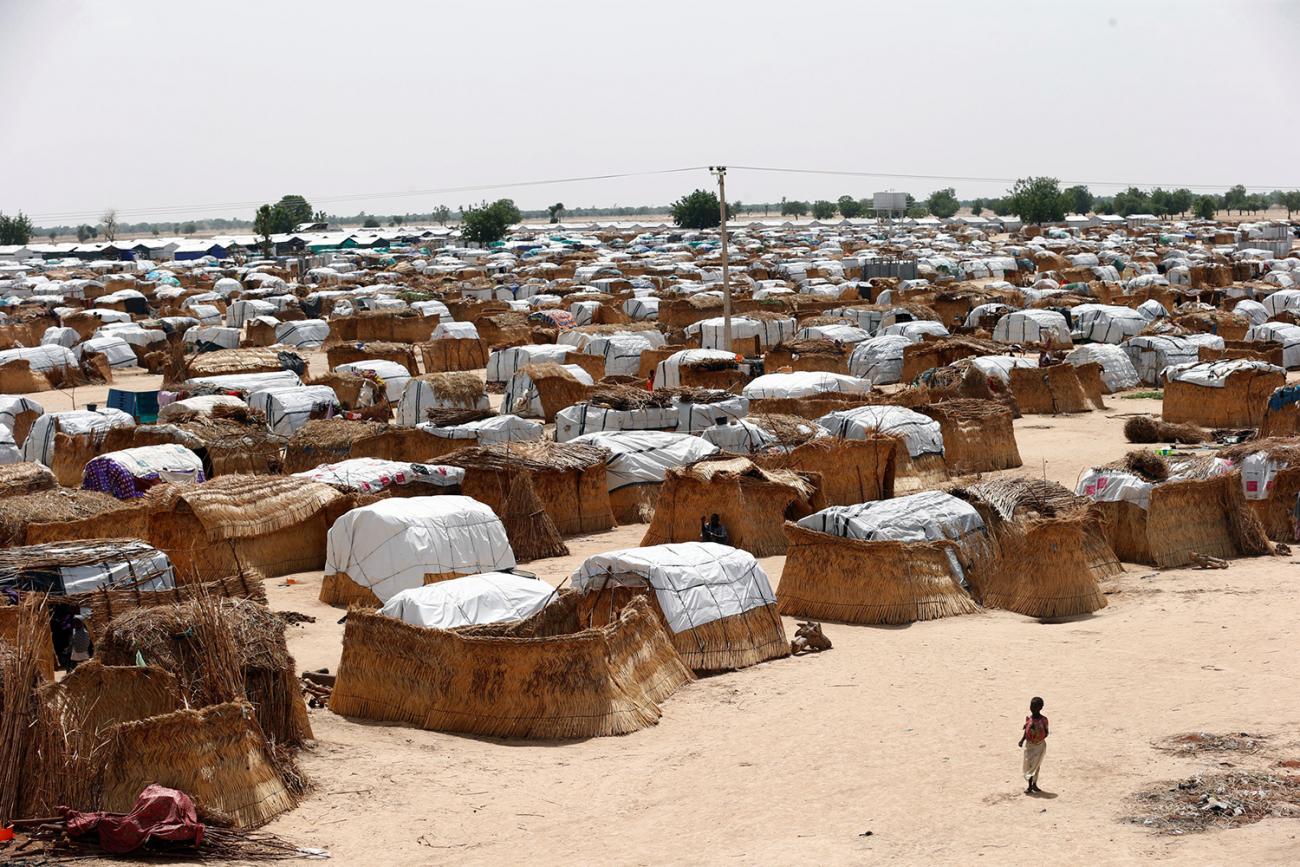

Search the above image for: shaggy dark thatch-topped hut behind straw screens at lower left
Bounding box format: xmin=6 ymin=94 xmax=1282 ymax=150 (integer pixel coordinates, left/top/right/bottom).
xmin=95 ymin=598 xmax=312 ymax=746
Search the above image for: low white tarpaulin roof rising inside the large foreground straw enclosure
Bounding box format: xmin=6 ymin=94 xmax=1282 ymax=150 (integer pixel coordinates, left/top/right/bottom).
xmin=380 ymin=572 xmax=555 ymax=629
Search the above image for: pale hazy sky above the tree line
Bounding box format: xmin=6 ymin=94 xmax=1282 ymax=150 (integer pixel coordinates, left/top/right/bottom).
xmin=0 ymin=0 xmax=1300 ymax=225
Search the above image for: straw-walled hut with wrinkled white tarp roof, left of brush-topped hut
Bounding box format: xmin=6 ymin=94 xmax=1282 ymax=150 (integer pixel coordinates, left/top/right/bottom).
xmin=776 ymin=491 xmax=987 ymax=624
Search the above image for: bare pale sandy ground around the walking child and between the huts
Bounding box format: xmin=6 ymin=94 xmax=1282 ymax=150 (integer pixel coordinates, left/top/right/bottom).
xmin=20 ymin=356 xmax=1300 ymax=864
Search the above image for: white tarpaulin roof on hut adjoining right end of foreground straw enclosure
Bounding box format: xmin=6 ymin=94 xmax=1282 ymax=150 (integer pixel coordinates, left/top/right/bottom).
xmin=569 ymin=542 xmax=776 ymax=633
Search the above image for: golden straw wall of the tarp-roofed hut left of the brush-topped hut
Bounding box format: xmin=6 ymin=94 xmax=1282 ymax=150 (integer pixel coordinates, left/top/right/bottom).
xmin=776 ymin=523 xmax=979 ymax=624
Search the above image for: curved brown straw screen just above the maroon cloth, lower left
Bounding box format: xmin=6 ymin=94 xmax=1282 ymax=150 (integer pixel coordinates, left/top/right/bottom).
xmin=101 ymin=702 xmax=298 ymax=828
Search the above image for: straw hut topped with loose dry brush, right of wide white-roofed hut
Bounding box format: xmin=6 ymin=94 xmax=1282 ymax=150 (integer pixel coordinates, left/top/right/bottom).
xmin=953 ymin=477 xmax=1123 ymax=617
